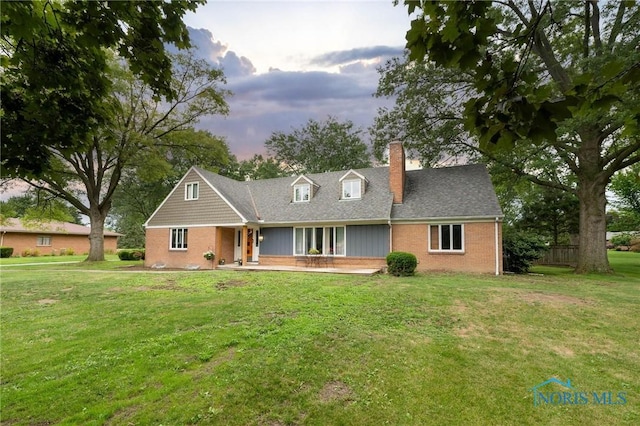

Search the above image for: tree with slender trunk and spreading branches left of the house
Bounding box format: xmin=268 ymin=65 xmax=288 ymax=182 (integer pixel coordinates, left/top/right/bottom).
xmin=8 ymin=55 xmax=228 ymax=261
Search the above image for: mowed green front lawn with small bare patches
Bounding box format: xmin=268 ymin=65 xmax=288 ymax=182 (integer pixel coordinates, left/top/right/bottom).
xmin=0 ymin=253 xmax=640 ymax=425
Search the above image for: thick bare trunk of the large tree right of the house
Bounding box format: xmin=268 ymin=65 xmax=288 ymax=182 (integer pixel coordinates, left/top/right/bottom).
xmin=576 ymin=175 xmax=611 ymax=274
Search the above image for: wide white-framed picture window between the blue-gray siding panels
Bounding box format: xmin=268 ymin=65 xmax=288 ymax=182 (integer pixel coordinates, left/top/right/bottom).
xmin=293 ymin=226 xmax=345 ymax=256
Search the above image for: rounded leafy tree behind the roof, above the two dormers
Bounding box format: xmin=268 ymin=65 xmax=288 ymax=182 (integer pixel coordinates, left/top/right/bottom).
xmin=265 ymin=117 xmax=371 ymax=174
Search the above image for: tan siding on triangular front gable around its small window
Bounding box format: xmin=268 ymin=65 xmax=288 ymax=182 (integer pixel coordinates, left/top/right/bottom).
xmin=147 ymin=170 xmax=241 ymax=226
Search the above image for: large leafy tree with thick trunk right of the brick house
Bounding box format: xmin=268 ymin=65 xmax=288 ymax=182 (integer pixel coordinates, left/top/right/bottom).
xmin=396 ymin=0 xmax=640 ymax=273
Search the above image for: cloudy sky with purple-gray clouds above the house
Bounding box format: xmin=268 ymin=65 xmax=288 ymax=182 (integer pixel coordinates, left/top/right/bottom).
xmin=185 ymin=0 xmax=410 ymax=159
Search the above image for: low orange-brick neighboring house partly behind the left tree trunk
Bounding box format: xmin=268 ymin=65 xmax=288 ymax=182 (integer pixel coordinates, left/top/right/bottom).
xmin=0 ymin=219 xmax=122 ymax=256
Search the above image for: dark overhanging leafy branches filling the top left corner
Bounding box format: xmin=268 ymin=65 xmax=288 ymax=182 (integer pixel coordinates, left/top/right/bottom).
xmin=0 ymin=0 xmax=204 ymax=176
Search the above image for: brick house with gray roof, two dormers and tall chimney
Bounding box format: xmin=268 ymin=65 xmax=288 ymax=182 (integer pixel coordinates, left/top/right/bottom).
xmin=145 ymin=142 xmax=503 ymax=274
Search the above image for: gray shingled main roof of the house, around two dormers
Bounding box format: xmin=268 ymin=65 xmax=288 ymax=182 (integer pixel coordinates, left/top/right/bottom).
xmin=196 ymin=165 xmax=502 ymax=224
